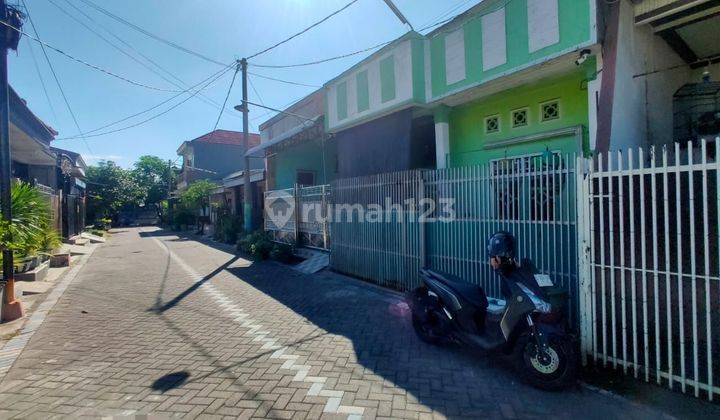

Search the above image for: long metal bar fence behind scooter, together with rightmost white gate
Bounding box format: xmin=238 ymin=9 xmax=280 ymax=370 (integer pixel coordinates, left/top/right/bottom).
xmin=266 ymin=139 xmax=720 ymax=400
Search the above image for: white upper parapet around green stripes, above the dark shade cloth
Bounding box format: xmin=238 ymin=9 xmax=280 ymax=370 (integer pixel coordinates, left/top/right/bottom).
xmin=327 ymin=40 xmax=413 ymax=130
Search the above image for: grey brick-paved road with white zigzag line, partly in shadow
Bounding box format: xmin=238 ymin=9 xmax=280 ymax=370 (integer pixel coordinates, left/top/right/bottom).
xmin=0 ymin=229 xmax=692 ymax=419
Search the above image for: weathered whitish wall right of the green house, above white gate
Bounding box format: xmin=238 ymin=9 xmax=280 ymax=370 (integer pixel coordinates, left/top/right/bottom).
xmin=610 ymin=2 xmax=720 ymax=150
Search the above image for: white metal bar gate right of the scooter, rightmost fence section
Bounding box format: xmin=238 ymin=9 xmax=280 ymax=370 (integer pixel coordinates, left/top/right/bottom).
xmin=578 ymin=140 xmax=720 ymax=400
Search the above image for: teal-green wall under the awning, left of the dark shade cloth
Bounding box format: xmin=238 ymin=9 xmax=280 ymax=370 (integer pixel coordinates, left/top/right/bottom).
xmin=273 ymin=139 xmax=337 ymax=190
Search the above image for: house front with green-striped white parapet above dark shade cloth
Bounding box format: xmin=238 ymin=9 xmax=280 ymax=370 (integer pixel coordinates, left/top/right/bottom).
xmin=325 ymin=32 xmax=435 ymax=178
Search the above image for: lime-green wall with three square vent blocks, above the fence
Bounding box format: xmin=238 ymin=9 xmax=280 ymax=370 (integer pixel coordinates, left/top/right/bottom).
xmin=449 ymin=71 xmax=590 ymax=166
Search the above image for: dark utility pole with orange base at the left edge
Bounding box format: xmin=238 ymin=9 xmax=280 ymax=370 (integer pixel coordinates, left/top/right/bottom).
xmin=0 ymin=0 xmax=23 ymax=321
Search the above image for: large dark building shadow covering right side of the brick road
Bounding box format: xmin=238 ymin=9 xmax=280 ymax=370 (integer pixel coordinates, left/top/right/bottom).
xmin=222 ymin=263 xmax=548 ymax=417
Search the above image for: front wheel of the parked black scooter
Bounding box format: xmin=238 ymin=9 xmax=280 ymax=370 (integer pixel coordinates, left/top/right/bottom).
xmin=515 ymin=334 xmax=577 ymax=391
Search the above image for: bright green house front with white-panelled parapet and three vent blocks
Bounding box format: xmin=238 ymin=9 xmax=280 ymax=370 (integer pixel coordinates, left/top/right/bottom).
xmin=425 ymin=0 xmax=600 ymax=167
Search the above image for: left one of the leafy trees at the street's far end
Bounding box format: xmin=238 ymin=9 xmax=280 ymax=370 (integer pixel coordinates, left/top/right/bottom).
xmin=86 ymin=161 xmax=147 ymax=220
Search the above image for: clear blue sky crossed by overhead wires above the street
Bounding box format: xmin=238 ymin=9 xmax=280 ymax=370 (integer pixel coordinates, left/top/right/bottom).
xmin=9 ymin=0 xmax=479 ymax=166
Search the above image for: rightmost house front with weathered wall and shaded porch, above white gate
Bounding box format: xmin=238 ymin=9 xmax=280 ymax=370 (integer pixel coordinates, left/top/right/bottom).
xmin=598 ymin=0 xmax=720 ymax=154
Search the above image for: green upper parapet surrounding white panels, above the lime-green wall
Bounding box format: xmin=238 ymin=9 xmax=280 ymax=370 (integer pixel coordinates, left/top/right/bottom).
xmin=430 ymin=0 xmax=592 ymax=97
